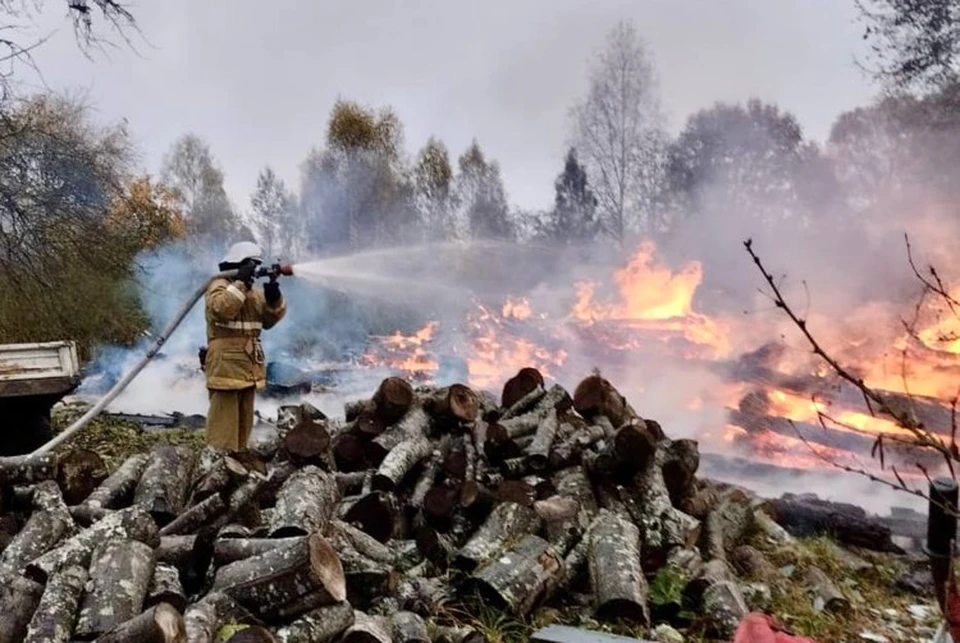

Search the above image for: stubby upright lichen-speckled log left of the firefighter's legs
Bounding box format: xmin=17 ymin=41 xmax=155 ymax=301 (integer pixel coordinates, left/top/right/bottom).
xmin=133 ymin=444 xmax=195 ymax=526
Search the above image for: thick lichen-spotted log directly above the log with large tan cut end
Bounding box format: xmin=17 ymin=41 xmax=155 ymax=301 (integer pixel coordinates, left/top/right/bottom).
xmin=270 ymin=465 xmax=340 ymax=538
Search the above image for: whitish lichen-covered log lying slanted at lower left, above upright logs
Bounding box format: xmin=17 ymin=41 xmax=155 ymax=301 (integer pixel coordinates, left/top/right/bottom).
xmin=24 ymin=506 xmax=160 ymax=583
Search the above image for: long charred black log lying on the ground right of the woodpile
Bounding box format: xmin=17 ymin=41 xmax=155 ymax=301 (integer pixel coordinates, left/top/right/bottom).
xmin=763 ymin=493 xmax=903 ymax=553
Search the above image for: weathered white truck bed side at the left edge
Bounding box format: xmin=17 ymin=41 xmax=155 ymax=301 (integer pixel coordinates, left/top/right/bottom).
xmin=0 ymin=341 xmax=80 ymax=397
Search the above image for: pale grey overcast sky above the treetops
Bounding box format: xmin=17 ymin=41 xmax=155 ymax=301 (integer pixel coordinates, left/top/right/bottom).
xmin=22 ymin=0 xmax=874 ymax=214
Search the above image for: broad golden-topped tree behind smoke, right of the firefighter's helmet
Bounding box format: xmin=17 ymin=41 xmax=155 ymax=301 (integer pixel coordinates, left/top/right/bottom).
xmin=301 ymin=100 xmax=418 ymax=250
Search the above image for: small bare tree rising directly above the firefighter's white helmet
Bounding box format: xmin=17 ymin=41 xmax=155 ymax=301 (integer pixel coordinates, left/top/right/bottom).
xmin=250 ymin=166 xmax=301 ymax=257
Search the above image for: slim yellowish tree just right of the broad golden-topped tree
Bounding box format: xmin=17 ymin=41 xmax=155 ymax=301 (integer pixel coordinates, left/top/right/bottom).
xmin=413 ymin=137 xmax=456 ymax=240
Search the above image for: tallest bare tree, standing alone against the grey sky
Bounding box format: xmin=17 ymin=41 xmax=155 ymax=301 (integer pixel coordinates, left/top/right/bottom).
xmin=573 ymin=22 xmax=666 ymax=242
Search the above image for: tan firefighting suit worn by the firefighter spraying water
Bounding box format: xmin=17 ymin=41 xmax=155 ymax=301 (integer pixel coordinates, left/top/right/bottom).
xmin=204 ymin=279 xmax=287 ymax=451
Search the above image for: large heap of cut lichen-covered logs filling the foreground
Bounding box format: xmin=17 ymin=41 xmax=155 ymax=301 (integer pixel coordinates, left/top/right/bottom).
xmin=0 ymin=369 xmax=829 ymax=643
